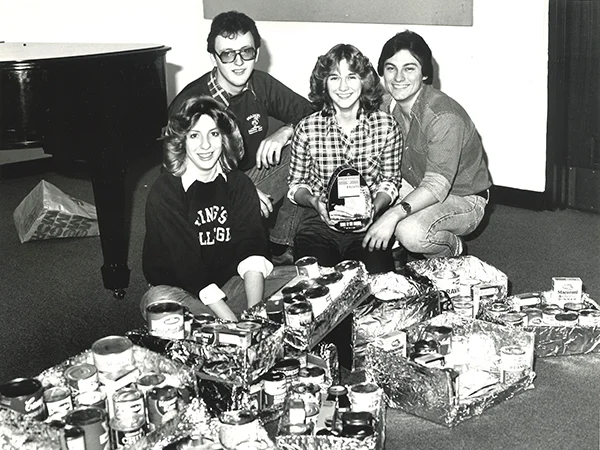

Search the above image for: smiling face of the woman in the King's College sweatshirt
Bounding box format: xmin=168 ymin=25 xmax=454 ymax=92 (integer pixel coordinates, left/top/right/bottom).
xmin=185 ymin=114 xmax=223 ymax=179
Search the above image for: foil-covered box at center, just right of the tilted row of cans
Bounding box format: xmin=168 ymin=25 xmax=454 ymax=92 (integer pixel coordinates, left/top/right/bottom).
xmin=352 ymin=272 xmax=441 ymax=370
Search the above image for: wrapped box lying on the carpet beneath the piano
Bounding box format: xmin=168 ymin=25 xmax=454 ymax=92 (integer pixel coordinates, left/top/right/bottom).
xmin=13 ymin=180 xmax=100 ymax=243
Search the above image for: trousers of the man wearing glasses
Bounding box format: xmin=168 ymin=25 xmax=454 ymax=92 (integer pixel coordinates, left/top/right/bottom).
xmin=245 ymin=147 xmax=300 ymax=247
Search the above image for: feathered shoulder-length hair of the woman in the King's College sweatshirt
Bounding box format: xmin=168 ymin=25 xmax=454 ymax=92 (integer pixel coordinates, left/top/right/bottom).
xmin=163 ymin=96 xmax=244 ymax=177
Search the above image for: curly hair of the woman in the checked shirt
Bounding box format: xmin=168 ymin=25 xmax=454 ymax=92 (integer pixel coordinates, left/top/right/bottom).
xmin=308 ymin=44 xmax=383 ymax=114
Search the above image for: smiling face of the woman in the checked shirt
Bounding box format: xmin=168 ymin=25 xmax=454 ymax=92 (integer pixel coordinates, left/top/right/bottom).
xmin=327 ymin=59 xmax=362 ymax=113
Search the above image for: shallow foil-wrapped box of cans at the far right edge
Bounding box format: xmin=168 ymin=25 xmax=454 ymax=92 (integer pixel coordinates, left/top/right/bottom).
xmin=480 ymin=291 xmax=600 ymax=357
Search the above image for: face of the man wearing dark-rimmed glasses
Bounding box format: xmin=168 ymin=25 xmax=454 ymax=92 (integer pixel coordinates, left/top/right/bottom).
xmin=210 ymin=32 xmax=258 ymax=95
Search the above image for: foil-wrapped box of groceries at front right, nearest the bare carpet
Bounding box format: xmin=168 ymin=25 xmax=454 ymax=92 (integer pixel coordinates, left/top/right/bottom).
xmin=365 ymin=312 xmax=535 ymax=427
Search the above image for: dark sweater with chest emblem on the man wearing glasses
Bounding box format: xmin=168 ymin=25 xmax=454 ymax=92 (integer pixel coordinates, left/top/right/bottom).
xmin=169 ymin=70 xmax=314 ymax=170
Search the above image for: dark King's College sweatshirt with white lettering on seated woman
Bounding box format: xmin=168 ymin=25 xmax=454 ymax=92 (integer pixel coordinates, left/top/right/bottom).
xmin=142 ymin=170 xmax=268 ymax=295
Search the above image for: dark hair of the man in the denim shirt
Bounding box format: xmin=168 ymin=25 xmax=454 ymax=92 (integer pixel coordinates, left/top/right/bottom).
xmin=377 ymin=30 xmax=434 ymax=84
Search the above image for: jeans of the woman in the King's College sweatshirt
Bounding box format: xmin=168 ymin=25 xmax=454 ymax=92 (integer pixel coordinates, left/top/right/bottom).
xmin=140 ymin=266 xmax=297 ymax=318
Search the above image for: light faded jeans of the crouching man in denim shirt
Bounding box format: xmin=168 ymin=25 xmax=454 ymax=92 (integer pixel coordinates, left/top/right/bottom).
xmin=394 ymin=185 xmax=487 ymax=258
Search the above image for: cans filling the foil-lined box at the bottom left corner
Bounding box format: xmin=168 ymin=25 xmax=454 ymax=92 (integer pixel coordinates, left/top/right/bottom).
xmin=0 ymin=336 xmax=184 ymax=450
